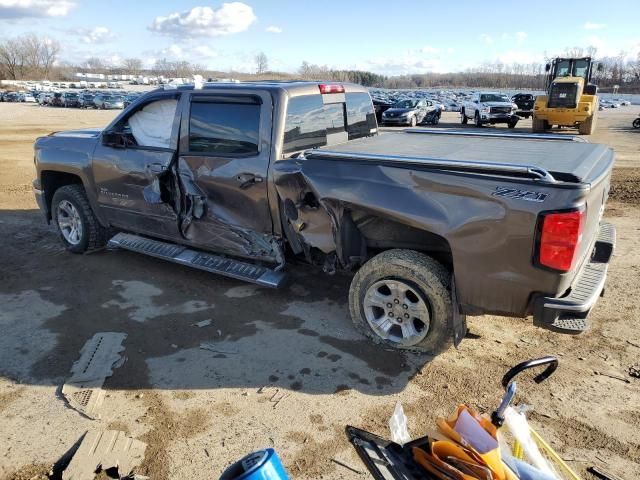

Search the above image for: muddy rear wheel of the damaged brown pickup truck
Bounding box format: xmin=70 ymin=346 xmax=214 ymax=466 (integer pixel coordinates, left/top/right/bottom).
xmin=349 ymin=250 xmax=453 ymax=354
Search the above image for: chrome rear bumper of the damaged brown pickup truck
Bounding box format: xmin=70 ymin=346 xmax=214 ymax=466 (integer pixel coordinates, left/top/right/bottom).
xmin=533 ymin=223 xmax=616 ymax=333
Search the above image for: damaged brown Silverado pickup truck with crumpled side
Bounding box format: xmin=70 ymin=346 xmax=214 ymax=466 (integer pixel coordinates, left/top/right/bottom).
xmin=34 ymin=82 xmax=615 ymax=353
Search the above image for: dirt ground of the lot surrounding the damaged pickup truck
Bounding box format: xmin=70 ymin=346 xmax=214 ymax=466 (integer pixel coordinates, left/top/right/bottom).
xmin=0 ymin=103 xmax=640 ymax=480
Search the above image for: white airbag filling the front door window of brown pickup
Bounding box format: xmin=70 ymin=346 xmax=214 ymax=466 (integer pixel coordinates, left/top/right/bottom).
xmin=129 ymin=98 xmax=178 ymax=148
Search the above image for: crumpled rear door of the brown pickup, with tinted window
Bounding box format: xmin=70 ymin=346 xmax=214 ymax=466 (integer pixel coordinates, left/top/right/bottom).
xmin=177 ymin=88 xmax=279 ymax=261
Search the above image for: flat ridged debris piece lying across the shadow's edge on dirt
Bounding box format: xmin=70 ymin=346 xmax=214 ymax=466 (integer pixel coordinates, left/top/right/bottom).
xmin=62 ymin=332 xmax=127 ymax=420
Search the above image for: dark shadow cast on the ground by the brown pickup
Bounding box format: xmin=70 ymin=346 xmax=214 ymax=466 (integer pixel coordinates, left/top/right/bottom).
xmin=0 ymin=210 xmax=428 ymax=395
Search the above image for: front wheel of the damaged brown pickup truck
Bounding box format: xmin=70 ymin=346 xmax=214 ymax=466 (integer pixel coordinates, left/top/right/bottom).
xmin=51 ymin=185 xmax=109 ymax=253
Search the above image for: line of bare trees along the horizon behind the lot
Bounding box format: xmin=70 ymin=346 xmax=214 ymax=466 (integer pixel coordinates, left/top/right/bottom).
xmin=0 ymin=34 xmax=640 ymax=92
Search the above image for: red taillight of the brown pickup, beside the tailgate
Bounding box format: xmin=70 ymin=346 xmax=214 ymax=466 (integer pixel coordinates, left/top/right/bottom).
xmin=538 ymin=209 xmax=585 ymax=272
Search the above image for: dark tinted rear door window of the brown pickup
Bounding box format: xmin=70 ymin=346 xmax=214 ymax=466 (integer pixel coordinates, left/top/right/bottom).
xmin=189 ymin=100 xmax=260 ymax=156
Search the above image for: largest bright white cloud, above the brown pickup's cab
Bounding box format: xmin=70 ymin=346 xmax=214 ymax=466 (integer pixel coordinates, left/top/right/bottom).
xmin=149 ymin=2 xmax=256 ymax=38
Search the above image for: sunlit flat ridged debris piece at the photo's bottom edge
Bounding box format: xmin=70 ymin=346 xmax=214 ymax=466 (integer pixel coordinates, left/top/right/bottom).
xmin=62 ymin=430 xmax=147 ymax=480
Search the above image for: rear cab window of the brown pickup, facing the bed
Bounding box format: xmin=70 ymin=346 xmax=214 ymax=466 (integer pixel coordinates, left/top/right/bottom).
xmin=282 ymin=92 xmax=378 ymax=155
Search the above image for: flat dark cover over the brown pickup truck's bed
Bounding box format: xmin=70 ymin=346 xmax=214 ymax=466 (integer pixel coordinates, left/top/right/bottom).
xmin=316 ymin=130 xmax=613 ymax=183
